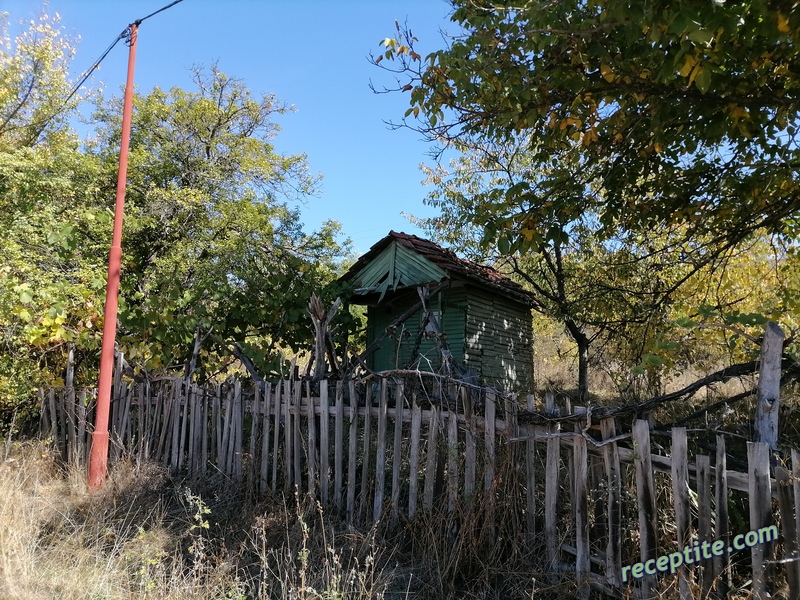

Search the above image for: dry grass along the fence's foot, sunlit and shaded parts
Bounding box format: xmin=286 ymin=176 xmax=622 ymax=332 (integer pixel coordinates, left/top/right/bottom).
xmin=0 ymin=442 xmax=574 ymax=600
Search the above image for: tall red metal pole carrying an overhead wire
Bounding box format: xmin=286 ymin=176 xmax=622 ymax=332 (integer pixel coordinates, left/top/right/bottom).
xmin=89 ymin=23 xmax=137 ymax=489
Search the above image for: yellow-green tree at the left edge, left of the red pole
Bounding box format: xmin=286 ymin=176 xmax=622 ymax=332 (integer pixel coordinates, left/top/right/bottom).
xmin=0 ymin=9 xmax=97 ymax=412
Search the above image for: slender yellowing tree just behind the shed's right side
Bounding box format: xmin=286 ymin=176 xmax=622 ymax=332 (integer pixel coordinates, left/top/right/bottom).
xmin=416 ymin=137 xmax=748 ymax=397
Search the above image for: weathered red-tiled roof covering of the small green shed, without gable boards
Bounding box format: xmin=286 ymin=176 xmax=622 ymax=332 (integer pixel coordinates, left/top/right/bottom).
xmin=339 ymin=231 xmax=536 ymax=307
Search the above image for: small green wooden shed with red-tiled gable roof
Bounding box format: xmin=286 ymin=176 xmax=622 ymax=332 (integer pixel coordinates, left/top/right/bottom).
xmin=341 ymin=231 xmax=534 ymax=391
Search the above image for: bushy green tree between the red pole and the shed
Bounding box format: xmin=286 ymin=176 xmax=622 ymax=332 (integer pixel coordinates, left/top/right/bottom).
xmin=92 ymin=66 xmax=350 ymax=380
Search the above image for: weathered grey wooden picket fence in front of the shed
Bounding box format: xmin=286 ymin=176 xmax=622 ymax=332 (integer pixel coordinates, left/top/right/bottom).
xmin=41 ymin=376 xmax=800 ymax=598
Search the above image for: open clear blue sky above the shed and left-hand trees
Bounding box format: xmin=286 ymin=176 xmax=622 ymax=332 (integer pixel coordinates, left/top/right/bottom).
xmin=0 ymin=0 xmax=455 ymax=252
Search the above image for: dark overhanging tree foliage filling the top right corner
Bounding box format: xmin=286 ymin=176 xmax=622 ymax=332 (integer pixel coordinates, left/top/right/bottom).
xmin=374 ymin=0 xmax=800 ymax=250
